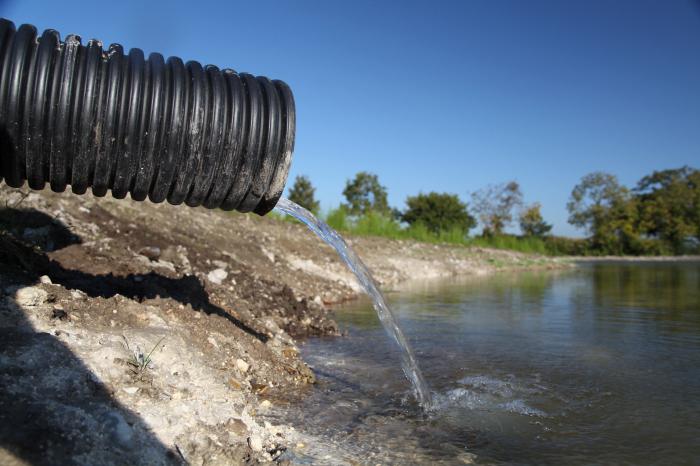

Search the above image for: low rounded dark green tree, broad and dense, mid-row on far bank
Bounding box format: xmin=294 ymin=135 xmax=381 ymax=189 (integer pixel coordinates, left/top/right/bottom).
xmin=401 ymin=192 xmax=476 ymax=234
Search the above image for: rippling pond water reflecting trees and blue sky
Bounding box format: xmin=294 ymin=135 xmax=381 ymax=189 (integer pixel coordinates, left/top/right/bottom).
xmin=272 ymin=262 xmax=700 ymax=465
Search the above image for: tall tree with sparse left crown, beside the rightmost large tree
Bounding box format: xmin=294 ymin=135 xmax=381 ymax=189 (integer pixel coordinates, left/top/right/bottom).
xmin=566 ymin=172 xmax=643 ymax=254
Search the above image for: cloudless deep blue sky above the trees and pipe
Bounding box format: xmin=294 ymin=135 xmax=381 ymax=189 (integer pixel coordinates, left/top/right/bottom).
xmin=0 ymin=0 xmax=700 ymax=235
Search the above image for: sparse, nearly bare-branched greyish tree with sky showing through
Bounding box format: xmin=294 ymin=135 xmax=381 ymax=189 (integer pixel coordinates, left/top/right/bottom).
xmin=472 ymin=181 xmax=523 ymax=236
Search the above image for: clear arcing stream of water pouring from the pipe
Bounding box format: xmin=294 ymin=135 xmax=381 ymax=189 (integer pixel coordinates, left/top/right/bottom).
xmin=275 ymin=197 xmax=432 ymax=410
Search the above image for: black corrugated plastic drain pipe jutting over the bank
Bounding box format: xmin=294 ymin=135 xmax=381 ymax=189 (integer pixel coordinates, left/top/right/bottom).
xmin=0 ymin=19 xmax=295 ymax=215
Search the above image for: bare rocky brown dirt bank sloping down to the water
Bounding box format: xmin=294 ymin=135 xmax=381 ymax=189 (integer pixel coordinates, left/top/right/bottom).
xmin=0 ymin=186 xmax=568 ymax=464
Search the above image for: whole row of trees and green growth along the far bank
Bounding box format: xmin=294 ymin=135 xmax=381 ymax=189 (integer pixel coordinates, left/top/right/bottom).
xmin=289 ymin=166 xmax=700 ymax=255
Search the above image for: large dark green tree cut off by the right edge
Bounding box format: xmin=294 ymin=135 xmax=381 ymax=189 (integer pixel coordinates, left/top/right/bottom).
xmin=634 ymin=166 xmax=700 ymax=253
